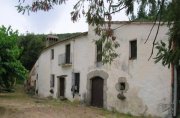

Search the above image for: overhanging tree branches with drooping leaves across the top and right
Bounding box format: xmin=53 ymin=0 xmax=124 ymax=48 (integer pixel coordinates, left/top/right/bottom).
xmin=17 ymin=0 xmax=180 ymax=65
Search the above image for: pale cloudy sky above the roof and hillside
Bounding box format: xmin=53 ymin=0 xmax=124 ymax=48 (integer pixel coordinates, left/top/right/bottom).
xmin=0 ymin=0 xmax=128 ymax=34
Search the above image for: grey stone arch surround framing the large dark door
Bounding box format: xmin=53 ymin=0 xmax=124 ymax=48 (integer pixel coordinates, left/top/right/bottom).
xmin=86 ymin=70 xmax=109 ymax=108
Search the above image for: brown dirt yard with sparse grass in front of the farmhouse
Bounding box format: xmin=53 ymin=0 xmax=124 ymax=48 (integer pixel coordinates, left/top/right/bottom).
xmin=0 ymin=86 xmax=149 ymax=118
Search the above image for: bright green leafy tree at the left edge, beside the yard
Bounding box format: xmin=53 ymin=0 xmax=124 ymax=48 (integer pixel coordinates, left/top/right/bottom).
xmin=0 ymin=26 xmax=27 ymax=91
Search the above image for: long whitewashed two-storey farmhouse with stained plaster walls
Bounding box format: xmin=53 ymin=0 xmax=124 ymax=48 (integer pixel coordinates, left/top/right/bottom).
xmin=30 ymin=21 xmax=180 ymax=117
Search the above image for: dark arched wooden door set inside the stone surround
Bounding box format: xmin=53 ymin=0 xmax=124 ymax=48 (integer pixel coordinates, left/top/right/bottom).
xmin=91 ymin=77 xmax=104 ymax=107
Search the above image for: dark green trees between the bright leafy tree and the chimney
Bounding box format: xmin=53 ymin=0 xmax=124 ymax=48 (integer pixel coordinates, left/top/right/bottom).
xmin=18 ymin=33 xmax=46 ymax=70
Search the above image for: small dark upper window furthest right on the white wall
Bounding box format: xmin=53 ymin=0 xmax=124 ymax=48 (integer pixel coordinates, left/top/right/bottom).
xmin=129 ymin=40 xmax=137 ymax=59
